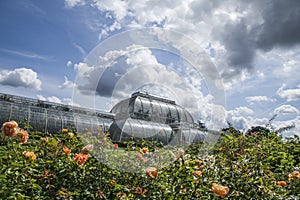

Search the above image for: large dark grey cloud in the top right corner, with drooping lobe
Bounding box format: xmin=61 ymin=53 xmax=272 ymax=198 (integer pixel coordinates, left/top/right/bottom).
xmin=212 ymin=0 xmax=300 ymax=79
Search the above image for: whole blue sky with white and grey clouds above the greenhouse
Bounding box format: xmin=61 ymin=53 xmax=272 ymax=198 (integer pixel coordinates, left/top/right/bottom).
xmin=0 ymin=0 xmax=300 ymax=136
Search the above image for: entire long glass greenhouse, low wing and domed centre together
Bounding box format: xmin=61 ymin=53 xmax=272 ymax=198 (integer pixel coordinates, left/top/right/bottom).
xmin=0 ymin=92 xmax=207 ymax=145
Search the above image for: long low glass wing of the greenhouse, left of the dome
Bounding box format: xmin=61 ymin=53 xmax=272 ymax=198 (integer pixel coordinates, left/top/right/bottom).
xmin=0 ymin=94 xmax=114 ymax=133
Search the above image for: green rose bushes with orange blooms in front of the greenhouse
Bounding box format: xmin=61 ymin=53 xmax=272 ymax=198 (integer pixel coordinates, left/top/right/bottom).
xmin=0 ymin=121 xmax=300 ymax=199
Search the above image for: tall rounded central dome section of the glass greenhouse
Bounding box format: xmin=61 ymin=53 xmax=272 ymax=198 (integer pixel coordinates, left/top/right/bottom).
xmin=109 ymin=92 xmax=206 ymax=145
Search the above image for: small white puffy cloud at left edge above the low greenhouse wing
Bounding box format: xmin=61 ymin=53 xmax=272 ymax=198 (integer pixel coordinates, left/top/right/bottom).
xmin=0 ymin=68 xmax=42 ymax=90
